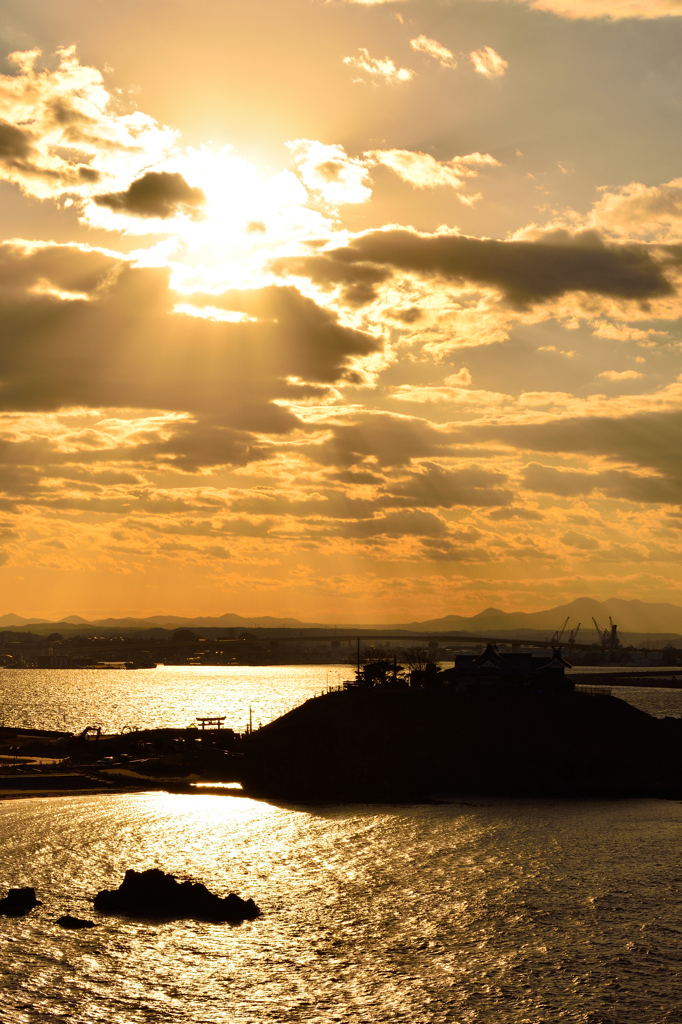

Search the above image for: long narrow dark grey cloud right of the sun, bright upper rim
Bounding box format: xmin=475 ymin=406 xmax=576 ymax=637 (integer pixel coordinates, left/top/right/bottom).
xmin=317 ymin=229 xmax=673 ymax=306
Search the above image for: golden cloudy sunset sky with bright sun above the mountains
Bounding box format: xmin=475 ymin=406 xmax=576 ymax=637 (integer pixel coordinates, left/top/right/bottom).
xmin=0 ymin=0 xmax=682 ymax=624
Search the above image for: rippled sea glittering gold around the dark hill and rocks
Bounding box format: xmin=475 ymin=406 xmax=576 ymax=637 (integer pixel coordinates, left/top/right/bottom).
xmin=0 ymin=666 xmax=682 ymax=1024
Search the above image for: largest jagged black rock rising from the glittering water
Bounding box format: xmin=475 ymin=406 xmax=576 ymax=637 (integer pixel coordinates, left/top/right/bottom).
xmin=94 ymin=867 xmax=260 ymax=922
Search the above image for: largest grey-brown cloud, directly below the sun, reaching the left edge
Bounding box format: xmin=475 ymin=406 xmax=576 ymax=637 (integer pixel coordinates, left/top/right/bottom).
xmin=0 ymin=244 xmax=381 ymax=466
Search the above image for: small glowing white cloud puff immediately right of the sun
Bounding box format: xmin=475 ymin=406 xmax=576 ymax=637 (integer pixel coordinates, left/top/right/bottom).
xmin=287 ymin=138 xmax=372 ymax=206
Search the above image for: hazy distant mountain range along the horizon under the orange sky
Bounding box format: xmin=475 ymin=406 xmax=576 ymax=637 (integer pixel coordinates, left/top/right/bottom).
xmin=0 ymin=597 xmax=682 ymax=633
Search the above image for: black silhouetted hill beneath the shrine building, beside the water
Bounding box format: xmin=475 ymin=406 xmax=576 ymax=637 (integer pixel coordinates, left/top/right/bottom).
xmin=238 ymin=687 xmax=682 ymax=801
